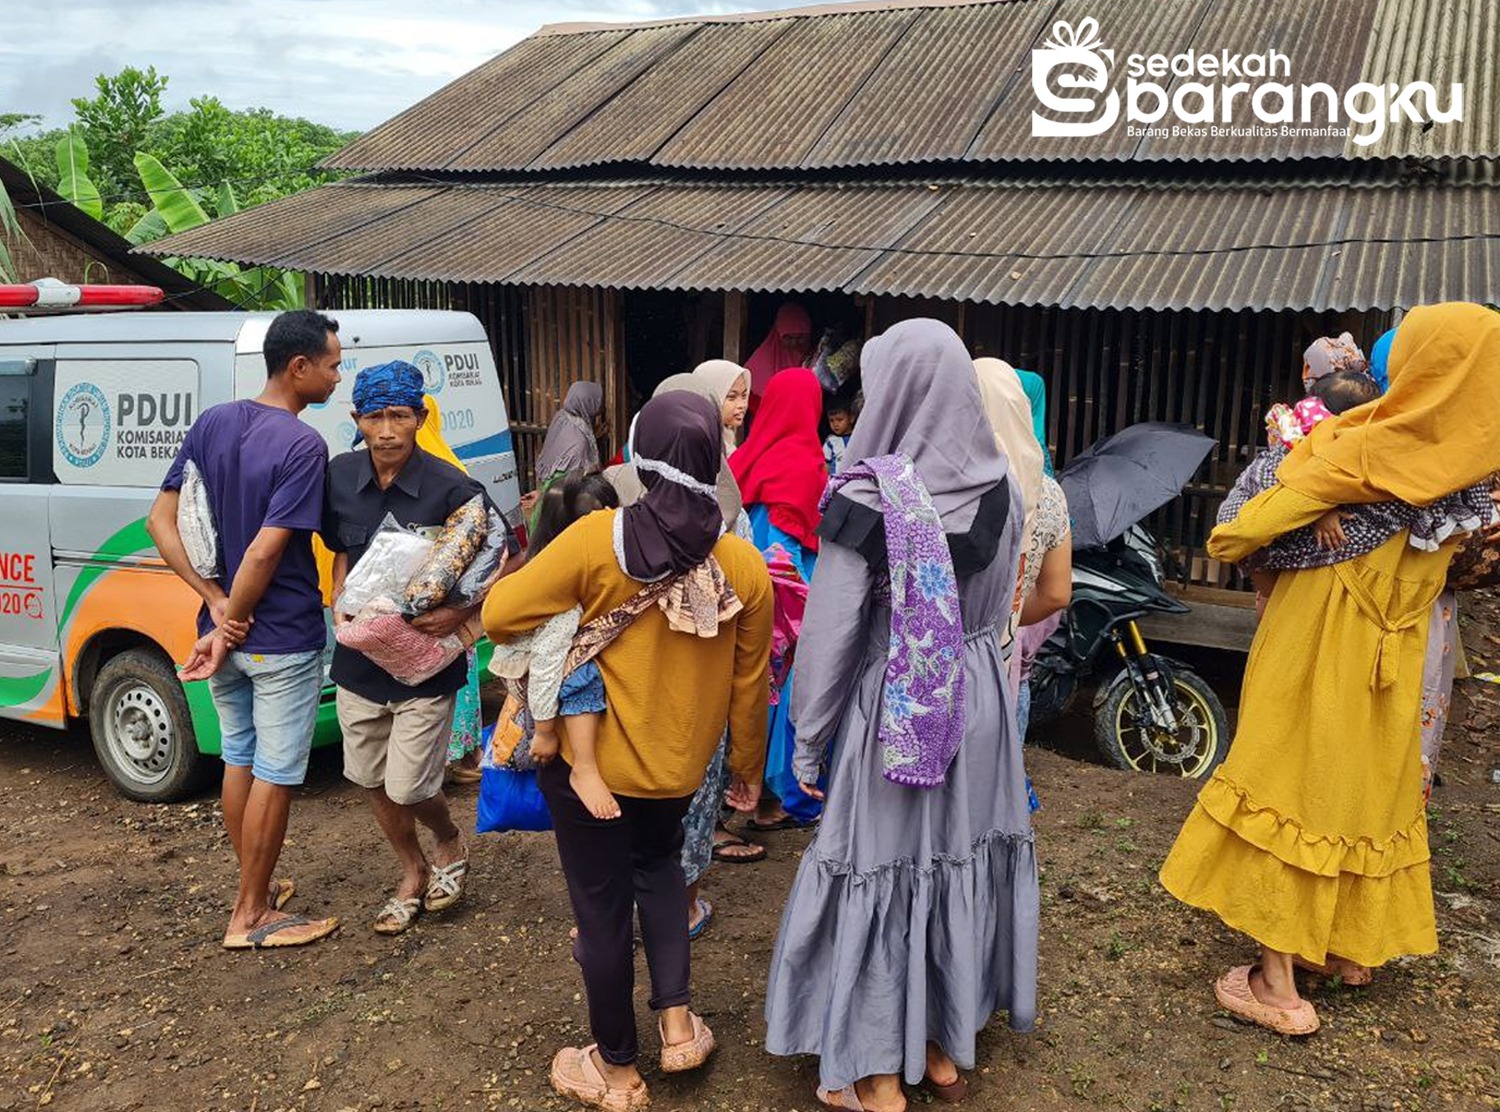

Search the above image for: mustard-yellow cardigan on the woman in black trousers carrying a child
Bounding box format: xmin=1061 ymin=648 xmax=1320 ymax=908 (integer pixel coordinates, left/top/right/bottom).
xmin=485 ymin=510 xmax=773 ymax=798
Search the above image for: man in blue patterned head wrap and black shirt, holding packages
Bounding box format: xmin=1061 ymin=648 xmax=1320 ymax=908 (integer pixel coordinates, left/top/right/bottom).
xmin=323 ymin=360 xmax=489 ymax=935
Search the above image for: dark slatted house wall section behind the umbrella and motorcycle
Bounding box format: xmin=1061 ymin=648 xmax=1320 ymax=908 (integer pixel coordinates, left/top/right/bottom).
xmin=965 ymin=305 xmax=1386 ymax=587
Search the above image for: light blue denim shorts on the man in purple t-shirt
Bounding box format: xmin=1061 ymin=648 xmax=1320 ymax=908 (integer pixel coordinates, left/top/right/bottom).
xmin=209 ymin=651 xmax=323 ymax=788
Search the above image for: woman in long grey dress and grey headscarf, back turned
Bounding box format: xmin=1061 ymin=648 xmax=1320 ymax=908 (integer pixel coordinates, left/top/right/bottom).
xmin=767 ymin=320 xmax=1038 ymax=1112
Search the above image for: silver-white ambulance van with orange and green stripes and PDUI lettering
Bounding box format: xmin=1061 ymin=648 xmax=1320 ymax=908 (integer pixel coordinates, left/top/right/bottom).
xmin=0 ymin=288 xmax=521 ymax=801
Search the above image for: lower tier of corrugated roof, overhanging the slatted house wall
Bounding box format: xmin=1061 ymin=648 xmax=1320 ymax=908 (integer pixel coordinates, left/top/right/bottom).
xmin=146 ymin=180 xmax=1500 ymax=311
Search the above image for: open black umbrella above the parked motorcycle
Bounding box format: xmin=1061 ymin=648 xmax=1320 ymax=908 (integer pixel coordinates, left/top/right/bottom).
xmin=1058 ymin=420 xmax=1218 ymax=548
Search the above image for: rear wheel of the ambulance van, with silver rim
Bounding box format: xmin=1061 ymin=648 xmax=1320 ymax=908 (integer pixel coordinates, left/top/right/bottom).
xmin=89 ymin=648 xmax=209 ymax=803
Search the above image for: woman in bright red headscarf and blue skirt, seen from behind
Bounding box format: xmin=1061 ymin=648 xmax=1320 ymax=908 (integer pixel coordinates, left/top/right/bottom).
xmin=729 ymin=368 xmax=828 ymax=831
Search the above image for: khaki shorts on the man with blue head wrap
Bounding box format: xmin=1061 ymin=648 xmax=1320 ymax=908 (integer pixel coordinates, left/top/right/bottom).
xmin=338 ymin=687 xmax=458 ymax=806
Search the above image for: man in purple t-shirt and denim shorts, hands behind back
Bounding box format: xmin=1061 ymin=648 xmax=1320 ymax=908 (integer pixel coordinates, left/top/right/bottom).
xmin=147 ymin=309 xmax=344 ymax=950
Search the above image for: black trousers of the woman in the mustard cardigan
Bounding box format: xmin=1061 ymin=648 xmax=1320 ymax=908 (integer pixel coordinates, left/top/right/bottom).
xmin=537 ymin=758 xmax=693 ymax=1065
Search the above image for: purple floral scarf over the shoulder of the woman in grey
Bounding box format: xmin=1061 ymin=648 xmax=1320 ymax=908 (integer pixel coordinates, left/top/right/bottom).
xmin=819 ymin=455 xmax=963 ymax=788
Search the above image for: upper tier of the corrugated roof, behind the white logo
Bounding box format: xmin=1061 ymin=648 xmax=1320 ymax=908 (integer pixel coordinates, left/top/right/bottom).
xmin=327 ymin=0 xmax=1500 ymax=173
